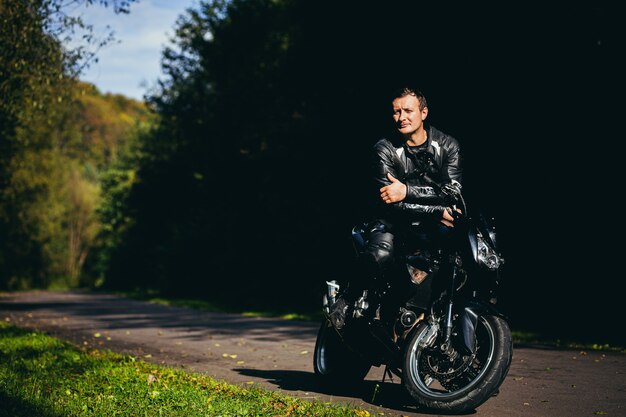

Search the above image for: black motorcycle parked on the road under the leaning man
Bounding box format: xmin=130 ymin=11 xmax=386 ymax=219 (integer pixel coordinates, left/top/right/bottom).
xmin=313 ymin=188 xmax=513 ymax=414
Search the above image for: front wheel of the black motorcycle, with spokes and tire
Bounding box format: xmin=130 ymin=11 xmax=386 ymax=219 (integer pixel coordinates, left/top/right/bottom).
xmin=402 ymin=315 xmax=513 ymax=414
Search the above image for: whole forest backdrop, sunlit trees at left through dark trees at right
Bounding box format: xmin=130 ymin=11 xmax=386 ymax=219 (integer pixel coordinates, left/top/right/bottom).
xmin=0 ymin=0 xmax=624 ymax=344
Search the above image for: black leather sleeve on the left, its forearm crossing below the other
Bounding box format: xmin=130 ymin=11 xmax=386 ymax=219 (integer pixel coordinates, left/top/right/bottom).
xmin=372 ymin=141 xmax=445 ymax=218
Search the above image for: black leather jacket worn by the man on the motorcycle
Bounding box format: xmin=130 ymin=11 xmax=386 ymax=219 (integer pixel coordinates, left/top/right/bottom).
xmin=373 ymin=126 xmax=462 ymax=228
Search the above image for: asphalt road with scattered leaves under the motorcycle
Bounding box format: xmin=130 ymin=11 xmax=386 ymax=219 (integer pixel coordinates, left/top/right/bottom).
xmin=0 ymin=292 xmax=626 ymax=417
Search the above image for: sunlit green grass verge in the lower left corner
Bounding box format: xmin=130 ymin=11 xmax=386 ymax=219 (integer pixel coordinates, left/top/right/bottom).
xmin=0 ymin=322 xmax=370 ymax=417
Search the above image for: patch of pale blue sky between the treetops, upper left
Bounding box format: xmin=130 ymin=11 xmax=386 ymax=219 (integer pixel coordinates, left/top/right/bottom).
xmin=66 ymin=0 xmax=198 ymax=100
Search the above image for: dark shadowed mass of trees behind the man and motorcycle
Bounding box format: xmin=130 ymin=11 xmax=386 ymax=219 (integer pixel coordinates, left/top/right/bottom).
xmin=98 ymin=0 xmax=618 ymax=339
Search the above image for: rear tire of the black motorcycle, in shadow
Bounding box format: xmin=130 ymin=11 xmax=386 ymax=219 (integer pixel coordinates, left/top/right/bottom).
xmin=313 ymin=320 xmax=371 ymax=386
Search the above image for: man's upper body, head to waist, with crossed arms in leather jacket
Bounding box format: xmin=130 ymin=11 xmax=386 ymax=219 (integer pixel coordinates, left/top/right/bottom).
xmin=374 ymin=87 xmax=462 ymax=227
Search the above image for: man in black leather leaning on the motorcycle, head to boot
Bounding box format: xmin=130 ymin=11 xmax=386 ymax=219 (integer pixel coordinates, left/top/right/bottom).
xmin=331 ymin=87 xmax=462 ymax=328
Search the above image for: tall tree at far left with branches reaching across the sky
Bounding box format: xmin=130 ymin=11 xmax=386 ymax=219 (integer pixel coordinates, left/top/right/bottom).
xmin=0 ymin=0 xmax=139 ymax=288
